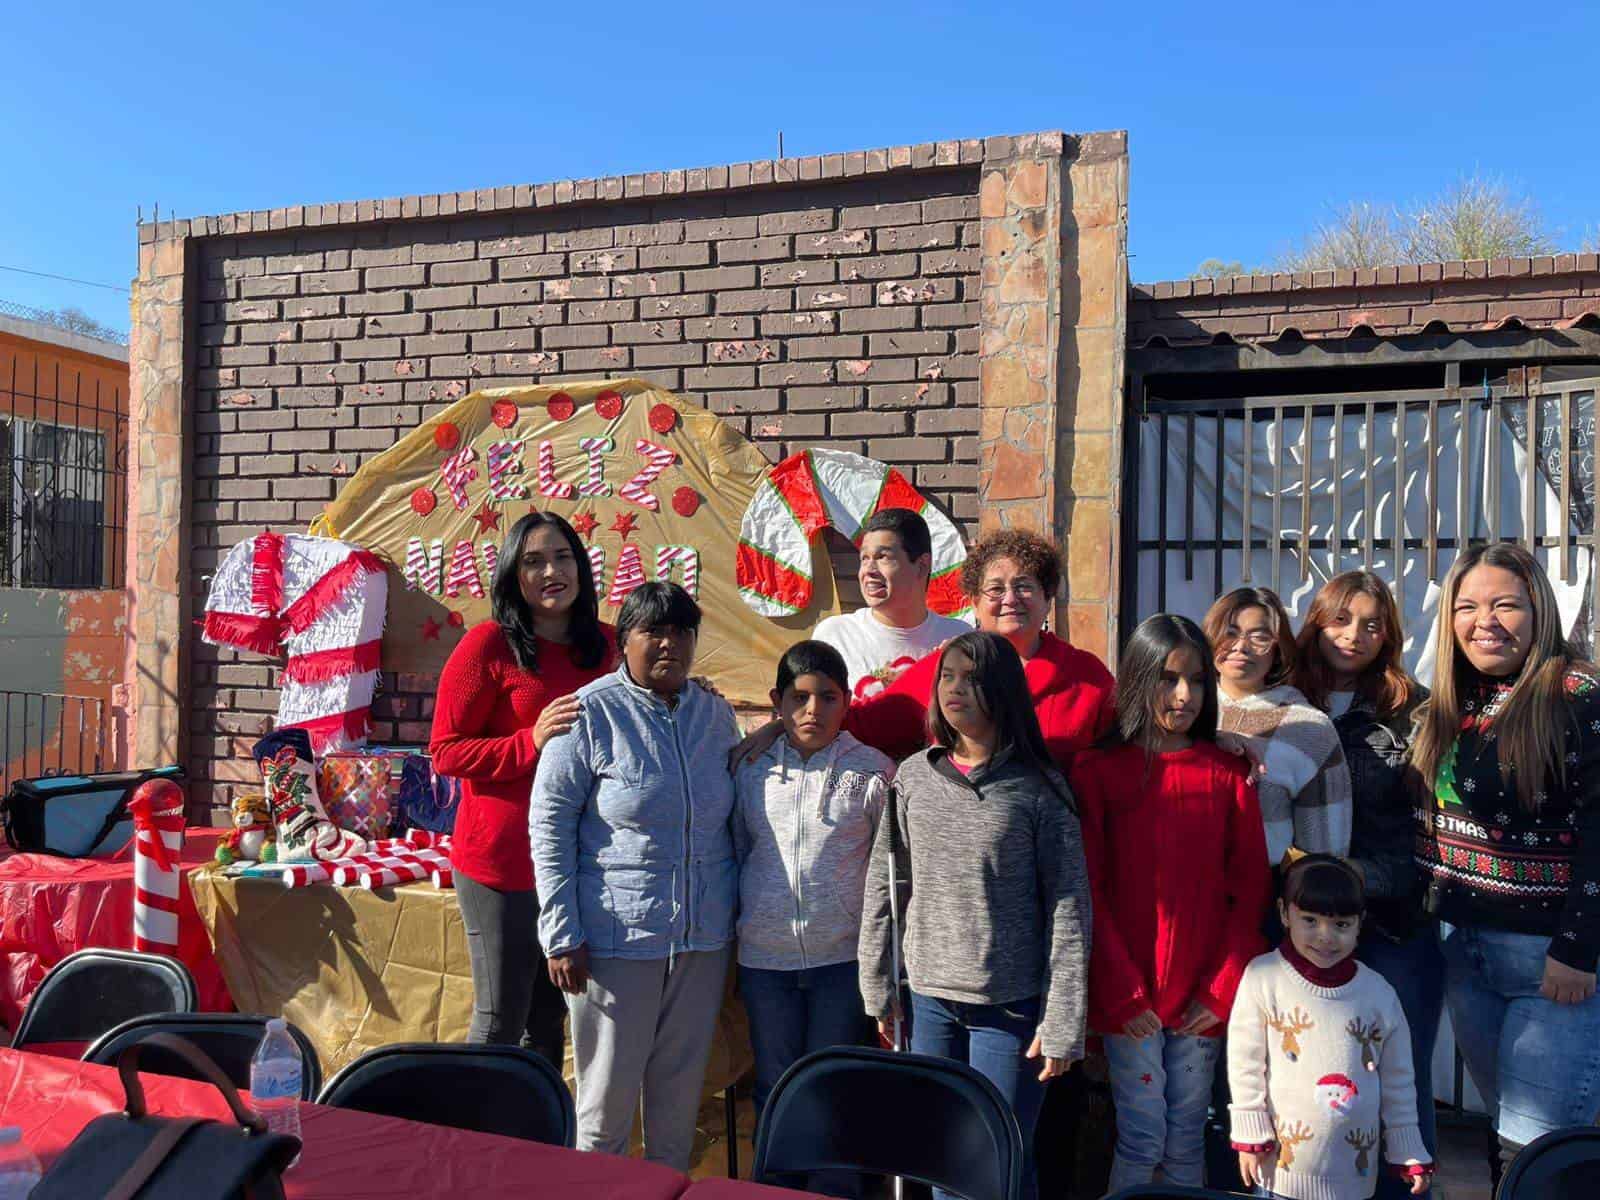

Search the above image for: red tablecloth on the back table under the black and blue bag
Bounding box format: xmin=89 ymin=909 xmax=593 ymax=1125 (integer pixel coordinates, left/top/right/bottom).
xmin=0 ymin=829 xmax=234 ymax=1029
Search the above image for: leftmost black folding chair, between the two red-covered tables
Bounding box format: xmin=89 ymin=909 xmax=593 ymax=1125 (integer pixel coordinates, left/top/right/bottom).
xmin=11 ymin=949 xmax=200 ymax=1050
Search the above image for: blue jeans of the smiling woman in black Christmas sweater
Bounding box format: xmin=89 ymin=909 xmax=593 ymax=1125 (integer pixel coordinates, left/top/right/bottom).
xmin=1443 ymin=928 xmax=1600 ymax=1146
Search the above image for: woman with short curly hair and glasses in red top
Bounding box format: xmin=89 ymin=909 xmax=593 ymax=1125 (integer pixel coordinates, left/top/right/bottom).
xmin=845 ymin=530 xmax=1115 ymax=770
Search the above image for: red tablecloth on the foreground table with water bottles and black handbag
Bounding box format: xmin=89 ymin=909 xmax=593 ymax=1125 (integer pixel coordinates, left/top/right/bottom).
xmin=0 ymin=1050 xmax=688 ymax=1200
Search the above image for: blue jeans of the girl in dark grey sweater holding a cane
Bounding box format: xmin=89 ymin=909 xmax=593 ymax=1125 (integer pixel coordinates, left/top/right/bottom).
xmin=910 ymin=992 xmax=1045 ymax=1200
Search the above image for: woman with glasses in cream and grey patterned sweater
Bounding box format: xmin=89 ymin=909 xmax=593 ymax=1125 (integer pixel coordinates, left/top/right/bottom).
xmin=1203 ymin=587 xmax=1350 ymax=866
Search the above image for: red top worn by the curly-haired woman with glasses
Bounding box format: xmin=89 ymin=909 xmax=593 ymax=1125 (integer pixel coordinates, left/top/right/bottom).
xmin=845 ymin=634 xmax=1120 ymax=764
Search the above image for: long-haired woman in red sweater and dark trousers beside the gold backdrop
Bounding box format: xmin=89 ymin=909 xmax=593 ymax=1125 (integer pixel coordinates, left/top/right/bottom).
xmin=429 ymin=512 xmax=613 ymax=1069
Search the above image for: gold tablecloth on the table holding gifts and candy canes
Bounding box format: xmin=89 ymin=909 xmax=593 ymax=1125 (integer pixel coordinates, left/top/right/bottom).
xmin=189 ymin=869 xmax=754 ymax=1093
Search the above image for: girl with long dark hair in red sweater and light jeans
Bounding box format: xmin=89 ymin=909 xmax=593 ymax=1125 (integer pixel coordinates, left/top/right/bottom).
xmin=1072 ymin=613 xmax=1272 ymax=1192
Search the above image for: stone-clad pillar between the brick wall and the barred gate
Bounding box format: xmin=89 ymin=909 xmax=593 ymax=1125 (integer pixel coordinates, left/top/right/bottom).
xmin=978 ymin=133 xmax=1128 ymax=662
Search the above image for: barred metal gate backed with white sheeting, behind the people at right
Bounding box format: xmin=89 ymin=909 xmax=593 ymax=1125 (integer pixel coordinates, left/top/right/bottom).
xmin=1125 ymin=363 xmax=1600 ymax=674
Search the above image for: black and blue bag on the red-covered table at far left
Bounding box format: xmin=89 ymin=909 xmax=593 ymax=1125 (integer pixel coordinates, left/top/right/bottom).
xmin=0 ymin=766 xmax=184 ymax=858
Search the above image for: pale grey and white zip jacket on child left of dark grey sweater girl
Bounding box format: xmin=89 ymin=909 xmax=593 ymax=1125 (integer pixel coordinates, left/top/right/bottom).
xmin=733 ymin=733 xmax=894 ymax=971
